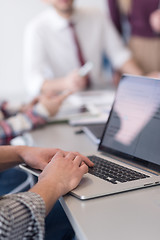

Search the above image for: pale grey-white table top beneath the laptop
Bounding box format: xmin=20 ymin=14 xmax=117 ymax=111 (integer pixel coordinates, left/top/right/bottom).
xmin=32 ymin=124 xmax=160 ymax=240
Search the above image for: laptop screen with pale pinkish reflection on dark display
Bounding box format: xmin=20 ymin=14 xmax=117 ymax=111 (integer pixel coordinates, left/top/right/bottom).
xmin=99 ymin=75 xmax=160 ymax=165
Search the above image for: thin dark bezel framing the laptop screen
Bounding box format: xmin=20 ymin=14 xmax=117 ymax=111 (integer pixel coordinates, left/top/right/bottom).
xmin=98 ymin=74 xmax=160 ymax=172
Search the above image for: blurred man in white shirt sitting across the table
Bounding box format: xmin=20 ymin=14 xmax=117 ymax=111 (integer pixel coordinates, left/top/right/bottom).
xmin=24 ymin=0 xmax=142 ymax=96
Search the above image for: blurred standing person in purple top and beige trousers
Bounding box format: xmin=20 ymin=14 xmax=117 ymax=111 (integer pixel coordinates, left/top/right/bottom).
xmin=108 ymin=0 xmax=160 ymax=78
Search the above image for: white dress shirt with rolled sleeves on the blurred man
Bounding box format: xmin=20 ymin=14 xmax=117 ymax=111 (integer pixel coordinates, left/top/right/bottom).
xmin=24 ymin=7 xmax=131 ymax=96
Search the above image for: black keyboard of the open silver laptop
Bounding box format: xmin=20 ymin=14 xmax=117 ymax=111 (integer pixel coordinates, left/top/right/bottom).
xmin=88 ymin=156 xmax=149 ymax=184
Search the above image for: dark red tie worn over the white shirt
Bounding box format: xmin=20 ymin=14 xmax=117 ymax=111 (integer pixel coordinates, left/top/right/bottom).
xmin=69 ymin=22 xmax=91 ymax=88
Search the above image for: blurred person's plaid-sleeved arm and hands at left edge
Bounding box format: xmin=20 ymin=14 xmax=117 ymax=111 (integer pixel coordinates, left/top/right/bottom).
xmin=0 ymin=92 xmax=71 ymax=145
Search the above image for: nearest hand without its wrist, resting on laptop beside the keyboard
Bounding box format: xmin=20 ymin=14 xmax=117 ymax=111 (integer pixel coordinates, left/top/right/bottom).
xmin=39 ymin=151 xmax=93 ymax=197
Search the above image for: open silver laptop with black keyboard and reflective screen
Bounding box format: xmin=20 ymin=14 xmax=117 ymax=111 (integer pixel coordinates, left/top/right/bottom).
xmin=20 ymin=75 xmax=160 ymax=200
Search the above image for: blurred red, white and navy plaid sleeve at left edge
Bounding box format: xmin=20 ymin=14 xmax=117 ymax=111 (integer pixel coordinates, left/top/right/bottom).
xmin=0 ymin=103 xmax=49 ymax=145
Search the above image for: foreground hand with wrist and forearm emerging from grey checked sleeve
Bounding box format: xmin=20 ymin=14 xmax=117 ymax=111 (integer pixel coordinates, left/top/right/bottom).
xmin=29 ymin=150 xmax=94 ymax=215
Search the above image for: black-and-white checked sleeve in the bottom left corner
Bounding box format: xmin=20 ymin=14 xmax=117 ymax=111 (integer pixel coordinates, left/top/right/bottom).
xmin=0 ymin=192 xmax=45 ymax=240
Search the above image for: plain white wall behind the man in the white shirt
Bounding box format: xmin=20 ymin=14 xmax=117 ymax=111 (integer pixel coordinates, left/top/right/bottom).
xmin=0 ymin=0 xmax=106 ymax=99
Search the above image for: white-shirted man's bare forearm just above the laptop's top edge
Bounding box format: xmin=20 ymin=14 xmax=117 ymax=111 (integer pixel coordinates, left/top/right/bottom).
xmin=119 ymin=59 xmax=143 ymax=75
